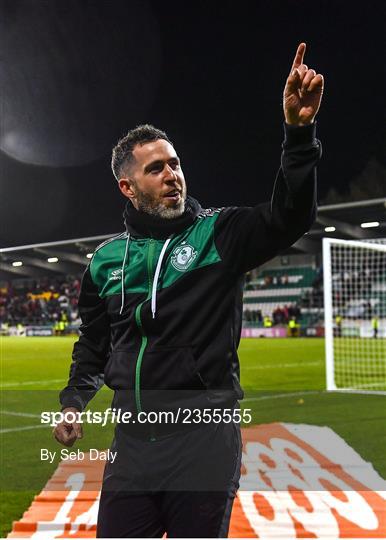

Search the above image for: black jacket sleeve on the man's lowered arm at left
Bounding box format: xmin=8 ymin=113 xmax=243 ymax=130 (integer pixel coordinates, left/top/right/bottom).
xmin=60 ymin=267 xmax=110 ymax=411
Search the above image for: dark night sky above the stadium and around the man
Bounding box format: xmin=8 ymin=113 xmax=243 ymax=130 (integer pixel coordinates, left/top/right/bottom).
xmin=0 ymin=0 xmax=385 ymax=247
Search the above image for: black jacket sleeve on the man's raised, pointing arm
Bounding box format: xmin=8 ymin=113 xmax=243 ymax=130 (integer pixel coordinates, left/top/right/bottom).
xmin=215 ymin=124 xmax=321 ymax=274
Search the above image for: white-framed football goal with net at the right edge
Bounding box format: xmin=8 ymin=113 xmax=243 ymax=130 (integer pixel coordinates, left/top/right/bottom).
xmin=323 ymin=238 xmax=386 ymax=392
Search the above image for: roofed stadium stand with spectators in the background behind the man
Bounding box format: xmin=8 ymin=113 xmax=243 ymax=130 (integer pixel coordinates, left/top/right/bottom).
xmin=0 ymin=198 xmax=386 ymax=335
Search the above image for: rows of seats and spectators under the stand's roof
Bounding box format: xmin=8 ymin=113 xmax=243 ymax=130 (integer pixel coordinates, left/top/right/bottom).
xmin=0 ymin=255 xmax=374 ymax=338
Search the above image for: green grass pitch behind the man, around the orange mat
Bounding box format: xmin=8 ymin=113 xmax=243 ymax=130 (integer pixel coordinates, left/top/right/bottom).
xmin=0 ymin=337 xmax=386 ymax=536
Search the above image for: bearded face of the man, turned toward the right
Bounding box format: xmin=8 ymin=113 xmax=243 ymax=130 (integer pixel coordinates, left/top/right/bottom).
xmin=119 ymin=139 xmax=186 ymax=219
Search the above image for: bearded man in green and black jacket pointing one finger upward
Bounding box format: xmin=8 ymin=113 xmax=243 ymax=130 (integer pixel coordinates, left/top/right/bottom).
xmin=55 ymin=43 xmax=323 ymax=537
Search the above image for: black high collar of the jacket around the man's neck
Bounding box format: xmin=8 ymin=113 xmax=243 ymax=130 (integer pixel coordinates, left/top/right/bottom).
xmin=123 ymin=196 xmax=201 ymax=239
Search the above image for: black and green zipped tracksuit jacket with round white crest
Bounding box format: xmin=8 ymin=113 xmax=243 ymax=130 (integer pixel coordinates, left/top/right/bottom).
xmin=60 ymin=124 xmax=321 ymax=422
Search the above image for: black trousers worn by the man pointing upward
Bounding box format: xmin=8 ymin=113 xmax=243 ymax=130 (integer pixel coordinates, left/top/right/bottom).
xmin=97 ymin=423 xmax=241 ymax=538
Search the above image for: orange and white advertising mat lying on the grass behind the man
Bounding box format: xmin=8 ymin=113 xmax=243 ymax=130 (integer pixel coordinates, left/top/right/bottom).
xmin=8 ymin=423 xmax=386 ymax=539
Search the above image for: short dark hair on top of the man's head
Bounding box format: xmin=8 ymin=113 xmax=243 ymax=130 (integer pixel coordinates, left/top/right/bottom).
xmin=111 ymin=124 xmax=173 ymax=180
